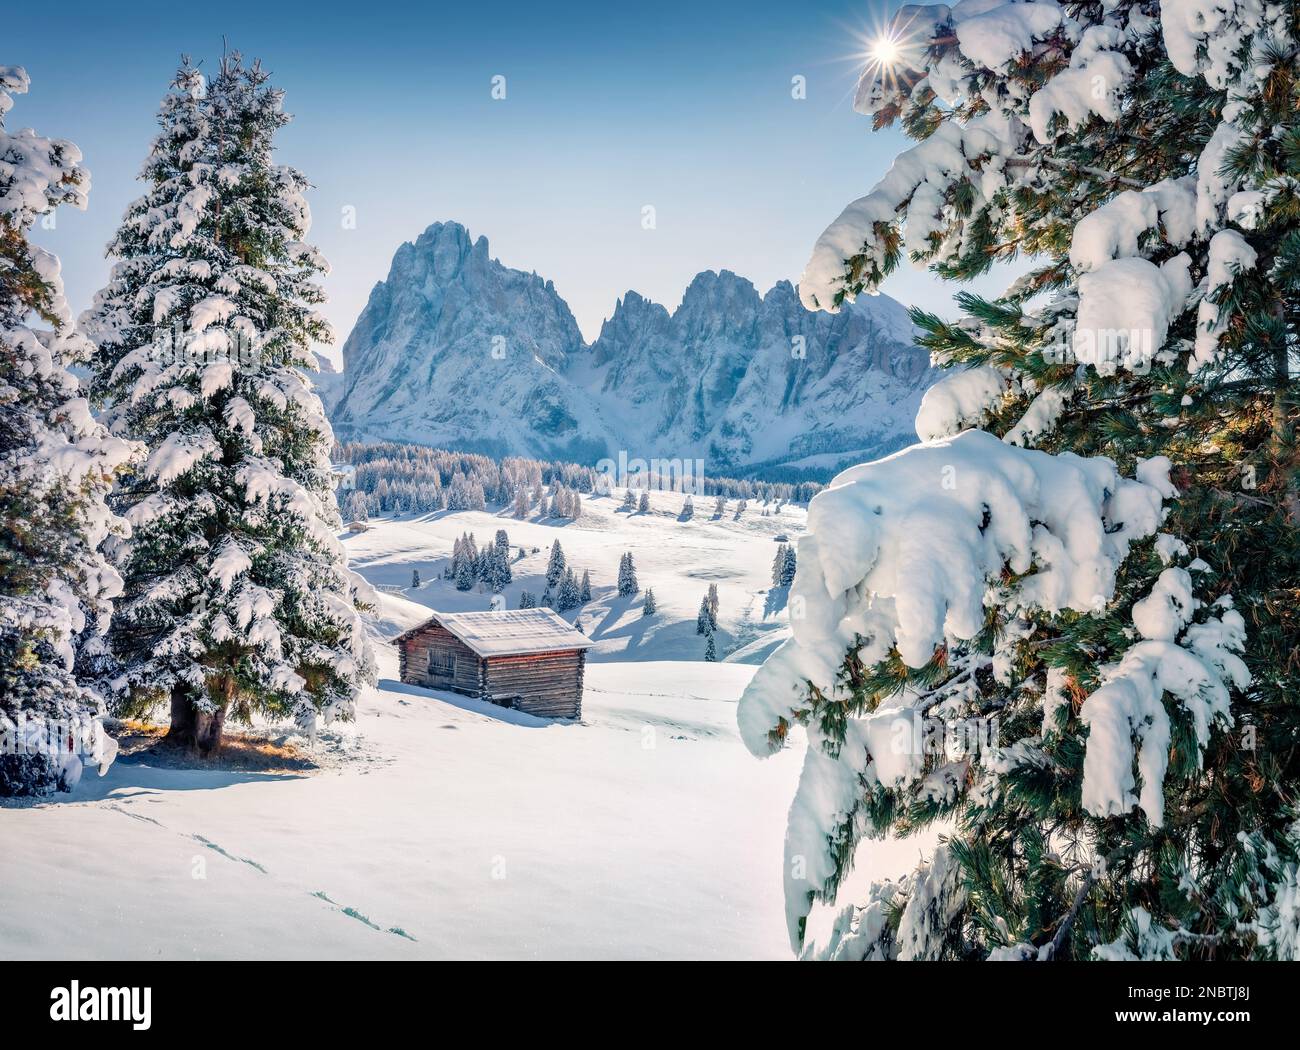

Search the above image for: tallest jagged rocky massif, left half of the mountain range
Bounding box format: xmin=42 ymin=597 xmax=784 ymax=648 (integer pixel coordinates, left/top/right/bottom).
xmin=330 ymin=222 xmax=621 ymax=461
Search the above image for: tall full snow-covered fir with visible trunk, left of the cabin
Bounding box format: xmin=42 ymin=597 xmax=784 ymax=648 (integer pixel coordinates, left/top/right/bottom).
xmin=85 ymin=55 xmax=374 ymax=754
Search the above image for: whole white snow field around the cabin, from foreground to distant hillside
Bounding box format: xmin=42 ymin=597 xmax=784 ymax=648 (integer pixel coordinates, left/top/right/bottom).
xmin=0 ymin=494 xmax=821 ymax=958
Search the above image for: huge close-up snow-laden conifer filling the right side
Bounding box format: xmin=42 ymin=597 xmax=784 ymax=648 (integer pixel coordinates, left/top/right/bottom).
xmin=740 ymin=0 xmax=1300 ymax=959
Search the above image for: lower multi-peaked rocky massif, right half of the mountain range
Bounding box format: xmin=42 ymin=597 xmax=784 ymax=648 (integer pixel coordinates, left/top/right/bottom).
xmin=592 ymin=270 xmax=932 ymax=473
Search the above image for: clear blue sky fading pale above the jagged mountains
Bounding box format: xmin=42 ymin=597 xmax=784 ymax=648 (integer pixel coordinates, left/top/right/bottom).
xmin=15 ymin=0 xmax=1005 ymax=356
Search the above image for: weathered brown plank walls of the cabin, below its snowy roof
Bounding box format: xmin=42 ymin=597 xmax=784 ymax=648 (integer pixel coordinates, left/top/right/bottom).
xmin=398 ymin=624 xmax=586 ymax=719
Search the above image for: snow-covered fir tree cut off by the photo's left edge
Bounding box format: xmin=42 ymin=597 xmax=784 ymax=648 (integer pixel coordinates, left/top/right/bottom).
xmin=0 ymin=66 xmax=140 ymax=795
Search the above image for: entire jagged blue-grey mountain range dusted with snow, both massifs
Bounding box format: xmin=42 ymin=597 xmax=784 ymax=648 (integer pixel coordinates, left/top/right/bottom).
xmin=326 ymin=222 xmax=933 ymax=476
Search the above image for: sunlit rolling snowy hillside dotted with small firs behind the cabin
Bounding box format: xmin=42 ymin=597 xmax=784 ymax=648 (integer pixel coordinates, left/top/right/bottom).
xmin=345 ymin=490 xmax=807 ymax=664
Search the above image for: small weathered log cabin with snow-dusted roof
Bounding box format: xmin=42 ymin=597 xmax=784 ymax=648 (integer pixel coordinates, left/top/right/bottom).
xmin=393 ymin=608 xmax=592 ymax=719
